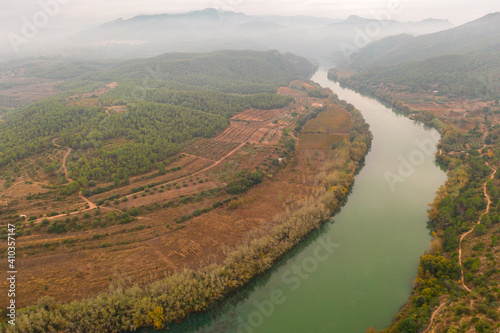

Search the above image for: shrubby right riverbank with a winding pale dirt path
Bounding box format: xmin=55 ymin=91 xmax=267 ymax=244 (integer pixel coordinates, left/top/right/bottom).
xmin=329 ymin=67 xmax=500 ymax=333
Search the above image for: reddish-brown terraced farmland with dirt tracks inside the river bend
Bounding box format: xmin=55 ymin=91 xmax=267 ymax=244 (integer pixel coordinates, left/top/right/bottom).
xmin=0 ymin=76 xmax=342 ymax=306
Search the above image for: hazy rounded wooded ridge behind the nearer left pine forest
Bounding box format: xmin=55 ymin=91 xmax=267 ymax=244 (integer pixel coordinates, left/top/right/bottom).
xmin=68 ymin=50 xmax=316 ymax=94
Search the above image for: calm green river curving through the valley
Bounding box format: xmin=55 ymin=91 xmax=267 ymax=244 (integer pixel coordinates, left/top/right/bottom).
xmin=151 ymin=69 xmax=446 ymax=333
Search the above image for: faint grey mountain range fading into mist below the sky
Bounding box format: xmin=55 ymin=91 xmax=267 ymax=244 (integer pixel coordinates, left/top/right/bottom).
xmin=18 ymin=8 xmax=453 ymax=63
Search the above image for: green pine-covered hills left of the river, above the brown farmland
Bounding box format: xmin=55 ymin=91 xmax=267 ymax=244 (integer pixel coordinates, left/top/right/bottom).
xmin=0 ymin=51 xmax=315 ymax=184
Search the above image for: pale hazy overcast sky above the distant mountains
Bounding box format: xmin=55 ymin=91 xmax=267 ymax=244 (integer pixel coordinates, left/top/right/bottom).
xmin=0 ymin=0 xmax=500 ymax=47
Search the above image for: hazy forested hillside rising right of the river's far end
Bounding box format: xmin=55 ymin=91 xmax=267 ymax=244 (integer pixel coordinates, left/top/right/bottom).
xmin=330 ymin=13 xmax=500 ymax=99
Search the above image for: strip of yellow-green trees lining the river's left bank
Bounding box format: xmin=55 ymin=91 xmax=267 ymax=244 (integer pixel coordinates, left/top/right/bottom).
xmin=3 ymin=84 xmax=371 ymax=331
